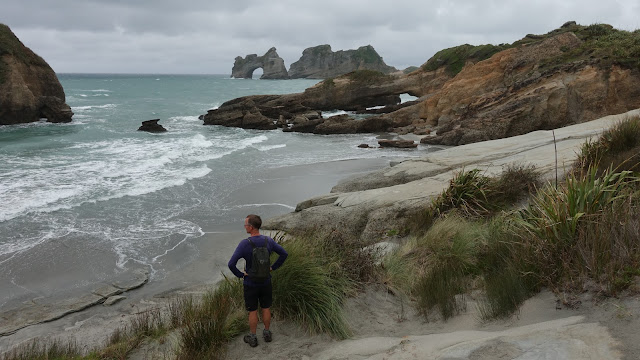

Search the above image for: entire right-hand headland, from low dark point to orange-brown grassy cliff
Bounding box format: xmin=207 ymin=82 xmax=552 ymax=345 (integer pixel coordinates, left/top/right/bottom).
xmin=209 ymin=22 xmax=640 ymax=145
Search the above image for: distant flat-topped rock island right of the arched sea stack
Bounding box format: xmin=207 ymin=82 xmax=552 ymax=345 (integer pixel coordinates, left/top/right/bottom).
xmin=289 ymin=45 xmax=398 ymax=79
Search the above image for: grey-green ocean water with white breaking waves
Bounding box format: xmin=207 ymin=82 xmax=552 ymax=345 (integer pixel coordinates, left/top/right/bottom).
xmin=0 ymin=74 xmax=418 ymax=307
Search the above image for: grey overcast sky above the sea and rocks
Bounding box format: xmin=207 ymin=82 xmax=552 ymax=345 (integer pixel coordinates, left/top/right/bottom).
xmin=0 ymin=0 xmax=640 ymax=74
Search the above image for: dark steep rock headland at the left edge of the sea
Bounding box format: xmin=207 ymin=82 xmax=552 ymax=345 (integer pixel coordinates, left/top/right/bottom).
xmin=0 ymin=24 xmax=73 ymax=125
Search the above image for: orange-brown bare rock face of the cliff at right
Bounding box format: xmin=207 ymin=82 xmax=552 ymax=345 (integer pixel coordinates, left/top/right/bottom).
xmin=419 ymin=32 xmax=640 ymax=145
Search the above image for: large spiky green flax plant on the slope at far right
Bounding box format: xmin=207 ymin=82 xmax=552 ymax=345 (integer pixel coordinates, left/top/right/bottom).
xmin=514 ymin=168 xmax=638 ymax=286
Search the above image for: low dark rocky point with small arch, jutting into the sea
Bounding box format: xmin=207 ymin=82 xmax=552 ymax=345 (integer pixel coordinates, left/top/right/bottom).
xmin=200 ymin=70 xmax=449 ymax=134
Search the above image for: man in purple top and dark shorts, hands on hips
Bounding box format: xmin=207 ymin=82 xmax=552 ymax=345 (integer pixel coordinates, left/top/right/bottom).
xmin=228 ymin=214 xmax=288 ymax=347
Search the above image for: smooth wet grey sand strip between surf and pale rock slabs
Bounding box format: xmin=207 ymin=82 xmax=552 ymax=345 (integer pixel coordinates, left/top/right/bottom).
xmin=0 ymin=158 xmax=395 ymax=352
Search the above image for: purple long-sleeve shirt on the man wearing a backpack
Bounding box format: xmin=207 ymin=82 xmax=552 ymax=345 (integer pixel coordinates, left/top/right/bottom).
xmin=227 ymin=235 xmax=289 ymax=286
